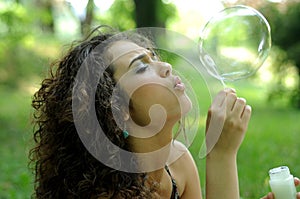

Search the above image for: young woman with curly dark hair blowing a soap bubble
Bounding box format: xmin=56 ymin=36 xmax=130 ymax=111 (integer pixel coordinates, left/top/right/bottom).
xmin=30 ymin=25 xmax=298 ymax=199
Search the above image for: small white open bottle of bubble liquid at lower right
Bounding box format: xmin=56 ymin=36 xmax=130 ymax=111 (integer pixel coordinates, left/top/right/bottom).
xmin=269 ymin=166 xmax=297 ymax=199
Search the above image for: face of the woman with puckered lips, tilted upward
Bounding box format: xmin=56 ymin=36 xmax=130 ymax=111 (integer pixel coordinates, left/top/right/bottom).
xmin=108 ymin=41 xmax=191 ymax=126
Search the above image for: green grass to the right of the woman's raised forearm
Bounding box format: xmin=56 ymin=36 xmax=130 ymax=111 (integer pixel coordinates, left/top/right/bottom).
xmin=238 ymin=107 xmax=300 ymax=199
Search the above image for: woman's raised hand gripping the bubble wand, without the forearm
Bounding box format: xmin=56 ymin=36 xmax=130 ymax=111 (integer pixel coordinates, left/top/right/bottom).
xmin=206 ymin=88 xmax=251 ymax=155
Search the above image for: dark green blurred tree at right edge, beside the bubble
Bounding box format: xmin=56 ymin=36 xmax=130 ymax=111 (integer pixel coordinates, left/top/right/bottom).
xmin=260 ymin=1 xmax=300 ymax=108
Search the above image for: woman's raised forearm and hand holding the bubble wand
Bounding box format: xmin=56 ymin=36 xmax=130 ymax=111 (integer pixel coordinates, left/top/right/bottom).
xmin=206 ymin=89 xmax=251 ymax=199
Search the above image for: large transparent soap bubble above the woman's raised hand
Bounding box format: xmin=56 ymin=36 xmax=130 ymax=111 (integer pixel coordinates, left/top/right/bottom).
xmin=199 ymin=6 xmax=271 ymax=82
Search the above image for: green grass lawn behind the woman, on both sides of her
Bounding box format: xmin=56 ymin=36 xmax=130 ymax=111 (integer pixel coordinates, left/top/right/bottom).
xmin=0 ymin=36 xmax=300 ymax=199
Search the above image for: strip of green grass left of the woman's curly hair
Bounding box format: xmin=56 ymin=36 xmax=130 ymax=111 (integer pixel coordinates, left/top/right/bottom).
xmin=0 ymin=87 xmax=33 ymax=199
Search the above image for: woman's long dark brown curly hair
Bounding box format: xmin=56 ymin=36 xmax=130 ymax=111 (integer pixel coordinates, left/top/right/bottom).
xmin=29 ymin=27 xmax=155 ymax=198
